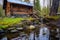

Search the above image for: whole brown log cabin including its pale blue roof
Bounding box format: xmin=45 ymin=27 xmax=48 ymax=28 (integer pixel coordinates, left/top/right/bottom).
xmin=3 ymin=0 xmax=34 ymax=16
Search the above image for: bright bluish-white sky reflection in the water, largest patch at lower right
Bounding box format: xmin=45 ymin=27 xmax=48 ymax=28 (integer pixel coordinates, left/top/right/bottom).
xmin=39 ymin=27 xmax=49 ymax=40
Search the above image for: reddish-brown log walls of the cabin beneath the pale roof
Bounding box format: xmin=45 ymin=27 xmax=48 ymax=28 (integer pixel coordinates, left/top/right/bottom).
xmin=6 ymin=2 xmax=33 ymax=16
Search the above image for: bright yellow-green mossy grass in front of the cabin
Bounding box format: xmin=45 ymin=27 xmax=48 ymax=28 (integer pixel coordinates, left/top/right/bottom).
xmin=0 ymin=17 xmax=33 ymax=29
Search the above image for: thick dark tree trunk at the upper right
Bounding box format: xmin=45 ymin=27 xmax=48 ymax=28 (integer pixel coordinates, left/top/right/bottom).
xmin=50 ymin=0 xmax=60 ymax=16
